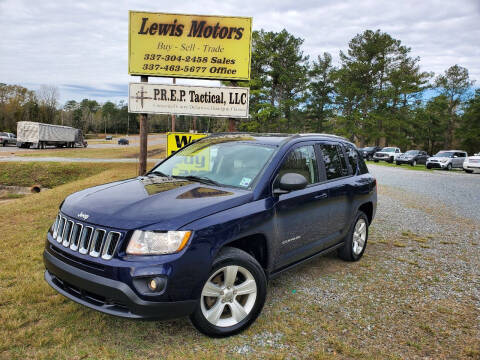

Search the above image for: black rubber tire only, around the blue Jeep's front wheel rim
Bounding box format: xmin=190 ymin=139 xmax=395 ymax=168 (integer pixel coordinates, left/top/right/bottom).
xmin=190 ymin=247 xmax=267 ymax=337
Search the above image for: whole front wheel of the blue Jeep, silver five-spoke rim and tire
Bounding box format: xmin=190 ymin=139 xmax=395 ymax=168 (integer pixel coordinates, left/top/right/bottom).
xmin=190 ymin=247 xmax=267 ymax=337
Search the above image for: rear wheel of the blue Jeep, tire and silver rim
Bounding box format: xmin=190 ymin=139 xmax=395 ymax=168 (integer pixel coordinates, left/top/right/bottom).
xmin=338 ymin=211 xmax=368 ymax=261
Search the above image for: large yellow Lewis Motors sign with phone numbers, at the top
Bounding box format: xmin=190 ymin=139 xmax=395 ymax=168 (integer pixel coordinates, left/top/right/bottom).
xmin=128 ymin=11 xmax=252 ymax=80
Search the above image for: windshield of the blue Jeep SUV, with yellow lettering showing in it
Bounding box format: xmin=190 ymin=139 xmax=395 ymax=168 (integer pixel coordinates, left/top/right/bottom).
xmin=151 ymin=136 xmax=276 ymax=188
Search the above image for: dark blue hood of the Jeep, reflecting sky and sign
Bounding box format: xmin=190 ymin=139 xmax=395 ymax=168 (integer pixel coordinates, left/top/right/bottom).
xmin=61 ymin=176 xmax=252 ymax=230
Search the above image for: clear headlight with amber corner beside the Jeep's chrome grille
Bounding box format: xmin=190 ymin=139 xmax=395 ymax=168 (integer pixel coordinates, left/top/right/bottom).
xmin=127 ymin=230 xmax=192 ymax=255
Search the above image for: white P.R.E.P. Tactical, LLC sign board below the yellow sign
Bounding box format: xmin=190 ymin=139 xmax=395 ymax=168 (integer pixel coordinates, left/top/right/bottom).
xmin=128 ymin=83 xmax=250 ymax=118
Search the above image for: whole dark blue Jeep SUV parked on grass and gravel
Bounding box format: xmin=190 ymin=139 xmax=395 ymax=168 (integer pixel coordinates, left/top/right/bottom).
xmin=44 ymin=133 xmax=377 ymax=337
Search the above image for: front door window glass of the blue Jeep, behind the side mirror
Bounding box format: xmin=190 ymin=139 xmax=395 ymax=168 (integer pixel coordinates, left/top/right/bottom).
xmin=278 ymin=145 xmax=318 ymax=184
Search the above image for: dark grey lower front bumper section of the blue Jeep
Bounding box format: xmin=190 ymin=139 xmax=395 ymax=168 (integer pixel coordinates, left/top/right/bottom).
xmin=43 ymin=251 xmax=197 ymax=319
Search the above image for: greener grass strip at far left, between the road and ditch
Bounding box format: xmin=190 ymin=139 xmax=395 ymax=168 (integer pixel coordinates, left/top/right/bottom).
xmin=0 ymin=162 xmax=125 ymax=188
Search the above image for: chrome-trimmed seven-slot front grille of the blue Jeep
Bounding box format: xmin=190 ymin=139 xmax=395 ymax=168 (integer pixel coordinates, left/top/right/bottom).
xmin=53 ymin=214 xmax=122 ymax=260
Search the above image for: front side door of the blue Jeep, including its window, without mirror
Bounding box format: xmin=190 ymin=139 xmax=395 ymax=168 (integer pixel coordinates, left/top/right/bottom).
xmin=272 ymin=142 xmax=330 ymax=269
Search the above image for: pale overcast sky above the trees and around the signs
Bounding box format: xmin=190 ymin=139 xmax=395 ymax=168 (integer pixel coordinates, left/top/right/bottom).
xmin=0 ymin=0 xmax=480 ymax=103
